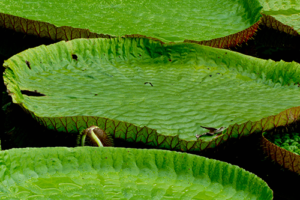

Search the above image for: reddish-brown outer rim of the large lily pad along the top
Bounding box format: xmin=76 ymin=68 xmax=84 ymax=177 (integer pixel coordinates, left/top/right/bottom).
xmin=0 ymin=13 xmax=261 ymax=49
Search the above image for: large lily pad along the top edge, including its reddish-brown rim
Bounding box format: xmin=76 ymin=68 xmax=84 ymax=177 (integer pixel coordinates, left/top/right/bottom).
xmin=0 ymin=0 xmax=262 ymax=47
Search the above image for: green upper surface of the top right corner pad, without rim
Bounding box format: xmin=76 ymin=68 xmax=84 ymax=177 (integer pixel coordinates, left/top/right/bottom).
xmin=259 ymin=0 xmax=300 ymax=34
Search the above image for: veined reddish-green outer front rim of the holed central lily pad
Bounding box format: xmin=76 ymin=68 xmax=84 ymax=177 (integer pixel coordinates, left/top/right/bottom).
xmin=19 ymin=104 xmax=300 ymax=152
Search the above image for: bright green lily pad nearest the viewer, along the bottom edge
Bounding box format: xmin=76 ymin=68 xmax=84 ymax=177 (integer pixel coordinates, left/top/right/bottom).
xmin=0 ymin=147 xmax=273 ymax=200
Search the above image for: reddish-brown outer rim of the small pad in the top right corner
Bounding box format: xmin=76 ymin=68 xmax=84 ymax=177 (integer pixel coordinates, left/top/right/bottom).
xmin=261 ymin=13 xmax=300 ymax=36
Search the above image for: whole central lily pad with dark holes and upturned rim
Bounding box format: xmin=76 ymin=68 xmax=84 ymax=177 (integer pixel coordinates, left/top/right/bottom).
xmin=4 ymin=38 xmax=300 ymax=151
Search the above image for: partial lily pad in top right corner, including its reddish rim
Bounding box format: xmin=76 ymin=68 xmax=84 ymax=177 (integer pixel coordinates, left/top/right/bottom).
xmin=259 ymin=0 xmax=300 ymax=36
